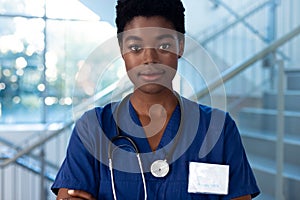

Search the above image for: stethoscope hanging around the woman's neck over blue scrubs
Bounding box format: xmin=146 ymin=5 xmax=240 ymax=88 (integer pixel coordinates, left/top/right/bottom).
xmin=108 ymin=93 xmax=183 ymax=200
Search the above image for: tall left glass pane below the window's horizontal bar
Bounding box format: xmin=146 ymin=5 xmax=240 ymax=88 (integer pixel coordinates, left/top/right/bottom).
xmin=0 ymin=17 xmax=44 ymax=123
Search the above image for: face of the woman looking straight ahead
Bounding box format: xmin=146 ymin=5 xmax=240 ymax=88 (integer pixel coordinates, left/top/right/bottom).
xmin=120 ymin=16 xmax=184 ymax=93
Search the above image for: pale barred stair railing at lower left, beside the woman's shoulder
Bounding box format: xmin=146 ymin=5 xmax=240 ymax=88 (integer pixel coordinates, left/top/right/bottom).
xmin=0 ymin=79 xmax=131 ymax=200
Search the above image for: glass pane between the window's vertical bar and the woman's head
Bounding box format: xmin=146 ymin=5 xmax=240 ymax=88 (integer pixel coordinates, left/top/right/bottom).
xmin=45 ymin=20 xmax=116 ymax=121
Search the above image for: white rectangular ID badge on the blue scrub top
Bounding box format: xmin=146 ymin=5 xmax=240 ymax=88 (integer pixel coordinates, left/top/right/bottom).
xmin=188 ymin=162 xmax=229 ymax=195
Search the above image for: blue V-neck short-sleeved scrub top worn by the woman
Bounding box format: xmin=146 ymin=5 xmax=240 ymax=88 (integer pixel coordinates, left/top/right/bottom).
xmin=51 ymin=98 xmax=260 ymax=200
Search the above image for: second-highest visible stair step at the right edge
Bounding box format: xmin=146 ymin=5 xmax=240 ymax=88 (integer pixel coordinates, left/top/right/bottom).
xmin=262 ymin=90 xmax=300 ymax=111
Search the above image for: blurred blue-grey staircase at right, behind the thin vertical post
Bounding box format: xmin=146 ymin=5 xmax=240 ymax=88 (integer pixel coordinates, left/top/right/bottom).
xmin=238 ymin=68 xmax=300 ymax=200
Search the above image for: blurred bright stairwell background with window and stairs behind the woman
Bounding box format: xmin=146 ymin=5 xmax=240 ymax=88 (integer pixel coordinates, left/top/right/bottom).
xmin=0 ymin=0 xmax=300 ymax=200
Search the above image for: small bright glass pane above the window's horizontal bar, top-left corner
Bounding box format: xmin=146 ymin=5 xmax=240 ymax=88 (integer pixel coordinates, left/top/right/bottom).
xmin=0 ymin=0 xmax=44 ymax=17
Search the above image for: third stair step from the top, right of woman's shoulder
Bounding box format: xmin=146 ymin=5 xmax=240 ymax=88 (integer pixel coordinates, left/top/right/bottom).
xmin=238 ymin=108 xmax=300 ymax=136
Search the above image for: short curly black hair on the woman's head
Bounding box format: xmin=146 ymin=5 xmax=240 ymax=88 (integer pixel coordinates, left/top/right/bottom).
xmin=116 ymin=0 xmax=185 ymax=34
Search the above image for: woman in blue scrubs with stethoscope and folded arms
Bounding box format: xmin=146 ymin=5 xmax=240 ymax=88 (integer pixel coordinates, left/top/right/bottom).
xmin=52 ymin=0 xmax=259 ymax=200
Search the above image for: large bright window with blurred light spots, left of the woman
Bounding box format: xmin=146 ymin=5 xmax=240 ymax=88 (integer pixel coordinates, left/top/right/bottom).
xmin=0 ymin=0 xmax=115 ymax=123
